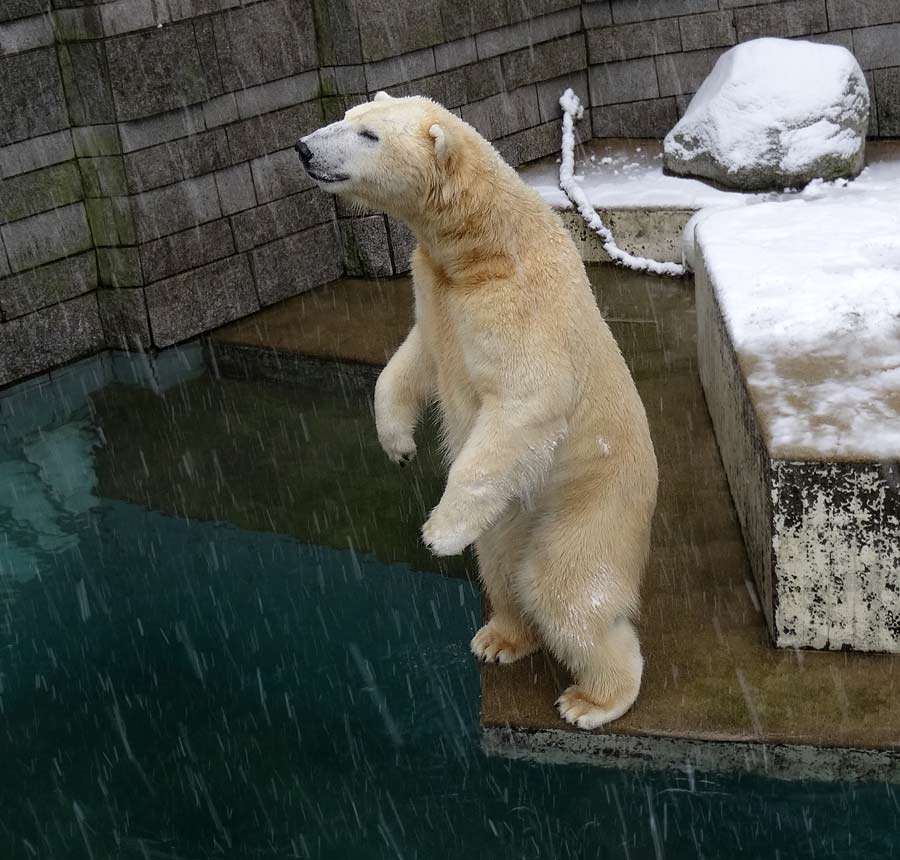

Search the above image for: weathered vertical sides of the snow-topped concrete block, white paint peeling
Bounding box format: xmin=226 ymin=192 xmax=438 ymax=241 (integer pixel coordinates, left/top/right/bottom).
xmin=696 ymin=249 xmax=900 ymax=652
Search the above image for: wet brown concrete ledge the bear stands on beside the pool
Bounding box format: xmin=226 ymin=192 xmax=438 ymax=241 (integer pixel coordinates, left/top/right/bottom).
xmin=211 ymin=266 xmax=900 ymax=781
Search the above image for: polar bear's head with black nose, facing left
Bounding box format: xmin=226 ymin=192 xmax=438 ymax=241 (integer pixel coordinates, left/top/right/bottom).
xmin=294 ymin=92 xmax=480 ymax=220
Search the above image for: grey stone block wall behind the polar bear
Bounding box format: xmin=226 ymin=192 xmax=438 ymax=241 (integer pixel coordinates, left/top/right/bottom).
xmin=0 ymin=0 xmax=900 ymax=385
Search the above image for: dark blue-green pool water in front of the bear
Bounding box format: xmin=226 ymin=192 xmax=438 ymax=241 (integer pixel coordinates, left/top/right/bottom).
xmin=0 ymin=350 xmax=900 ymax=860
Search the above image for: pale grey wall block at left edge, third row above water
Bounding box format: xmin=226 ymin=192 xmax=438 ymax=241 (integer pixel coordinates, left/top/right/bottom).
xmin=0 ymin=203 xmax=91 ymax=272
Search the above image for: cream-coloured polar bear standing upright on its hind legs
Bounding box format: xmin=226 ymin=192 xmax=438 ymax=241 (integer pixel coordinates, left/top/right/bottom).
xmin=296 ymin=93 xmax=658 ymax=729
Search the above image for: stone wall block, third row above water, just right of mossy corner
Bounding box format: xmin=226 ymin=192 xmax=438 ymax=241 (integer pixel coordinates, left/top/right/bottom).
xmin=131 ymin=175 xmax=222 ymax=242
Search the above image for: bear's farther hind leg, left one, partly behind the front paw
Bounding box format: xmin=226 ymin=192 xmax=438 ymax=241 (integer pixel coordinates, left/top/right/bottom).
xmin=471 ymin=505 xmax=540 ymax=663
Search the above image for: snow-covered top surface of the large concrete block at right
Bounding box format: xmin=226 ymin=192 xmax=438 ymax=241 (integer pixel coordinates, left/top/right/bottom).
xmin=696 ymin=191 xmax=900 ymax=461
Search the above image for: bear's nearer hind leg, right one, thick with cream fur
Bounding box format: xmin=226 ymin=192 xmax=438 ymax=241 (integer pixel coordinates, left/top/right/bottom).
xmin=517 ymin=504 xmax=650 ymax=729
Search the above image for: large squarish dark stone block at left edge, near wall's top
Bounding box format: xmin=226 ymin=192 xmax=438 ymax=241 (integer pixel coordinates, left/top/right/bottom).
xmin=0 ymin=48 xmax=69 ymax=146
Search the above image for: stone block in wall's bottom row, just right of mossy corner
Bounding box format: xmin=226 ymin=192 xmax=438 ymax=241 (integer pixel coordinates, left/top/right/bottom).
xmin=145 ymin=254 xmax=259 ymax=347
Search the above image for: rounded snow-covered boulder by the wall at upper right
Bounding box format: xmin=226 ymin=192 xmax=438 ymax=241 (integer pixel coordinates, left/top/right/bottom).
xmin=664 ymin=39 xmax=869 ymax=191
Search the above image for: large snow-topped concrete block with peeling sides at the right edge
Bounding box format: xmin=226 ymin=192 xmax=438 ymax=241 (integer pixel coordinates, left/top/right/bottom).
xmin=695 ymin=193 xmax=900 ymax=652
